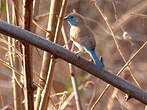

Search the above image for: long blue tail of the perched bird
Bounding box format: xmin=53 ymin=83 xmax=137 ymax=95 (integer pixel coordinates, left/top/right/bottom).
xmin=86 ymin=49 xmax=104 ymax=68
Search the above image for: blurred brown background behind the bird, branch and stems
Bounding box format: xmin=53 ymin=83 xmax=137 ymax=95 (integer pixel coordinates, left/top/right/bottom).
xmin=0 ymin=0 xmax=147 ymax=110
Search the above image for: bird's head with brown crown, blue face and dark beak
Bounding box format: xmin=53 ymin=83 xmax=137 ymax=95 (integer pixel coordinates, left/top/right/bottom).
xmin=64 ymin=13 xmax=84 ymax=26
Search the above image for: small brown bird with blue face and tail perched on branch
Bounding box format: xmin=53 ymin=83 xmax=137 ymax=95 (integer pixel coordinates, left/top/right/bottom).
xmin=64 ymin=12 xmax=104 ymax=68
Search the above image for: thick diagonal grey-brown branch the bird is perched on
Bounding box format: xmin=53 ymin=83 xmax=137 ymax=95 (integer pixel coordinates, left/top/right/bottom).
xmin=0 ymin=21 xmax=147 ymax=104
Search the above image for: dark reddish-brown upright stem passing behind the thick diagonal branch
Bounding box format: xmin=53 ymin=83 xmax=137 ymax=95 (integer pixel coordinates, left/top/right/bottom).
xmin=23 ymin=0 xmax=34 ymax=110
